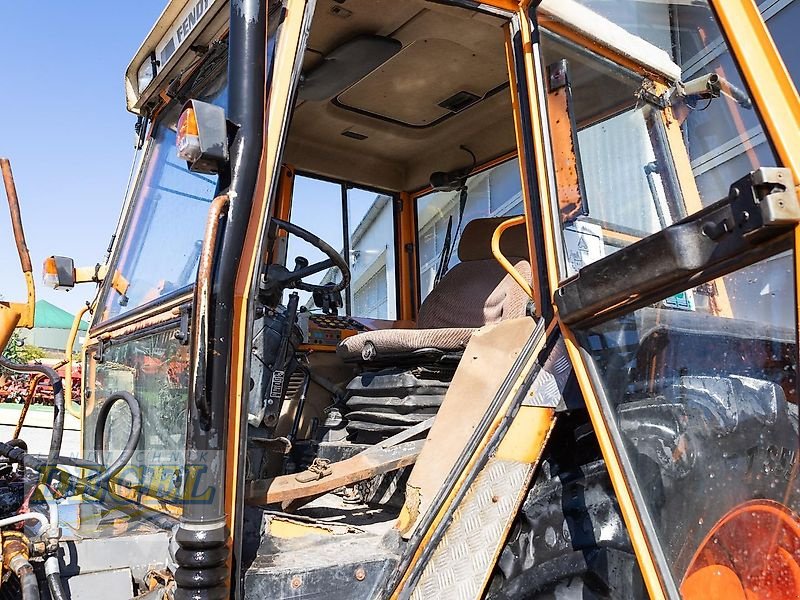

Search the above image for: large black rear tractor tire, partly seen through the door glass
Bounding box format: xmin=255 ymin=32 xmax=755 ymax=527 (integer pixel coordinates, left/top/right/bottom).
xmin=487 ymin=376 xmax=800 ymax=600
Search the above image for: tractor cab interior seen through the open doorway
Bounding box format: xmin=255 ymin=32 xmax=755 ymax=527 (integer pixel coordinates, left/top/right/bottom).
xmin=247 ymin=0 xmax=640 ymax=548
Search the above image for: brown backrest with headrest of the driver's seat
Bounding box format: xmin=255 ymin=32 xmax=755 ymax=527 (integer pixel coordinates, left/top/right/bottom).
xmin=417 ymin=217 xmax=531 ymax=329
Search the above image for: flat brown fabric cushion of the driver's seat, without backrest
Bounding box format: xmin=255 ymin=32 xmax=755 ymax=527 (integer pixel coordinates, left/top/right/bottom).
xmin=336 ymin=327 xmax=476 ymax=361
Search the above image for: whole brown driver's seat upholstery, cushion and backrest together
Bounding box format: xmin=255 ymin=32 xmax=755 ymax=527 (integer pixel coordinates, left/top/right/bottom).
xmin=336 ymin=217 xmax=531 ymax=361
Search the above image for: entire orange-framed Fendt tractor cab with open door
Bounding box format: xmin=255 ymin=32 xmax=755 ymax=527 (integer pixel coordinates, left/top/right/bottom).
xmin=0 ymin=0 xmax=800 ymax=600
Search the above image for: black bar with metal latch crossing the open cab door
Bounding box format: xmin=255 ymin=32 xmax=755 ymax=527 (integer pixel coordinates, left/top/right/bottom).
xmin=555 ymin=167 xmax=800 ymax=327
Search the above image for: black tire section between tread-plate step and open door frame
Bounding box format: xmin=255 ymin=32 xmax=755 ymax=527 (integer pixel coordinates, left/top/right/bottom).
xmin=487 ymin=436 xmax=647 ymax=600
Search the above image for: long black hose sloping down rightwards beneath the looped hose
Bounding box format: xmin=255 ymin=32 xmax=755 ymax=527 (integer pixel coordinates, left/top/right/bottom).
xmin=0 ymin=442 xmax=178 ymax=529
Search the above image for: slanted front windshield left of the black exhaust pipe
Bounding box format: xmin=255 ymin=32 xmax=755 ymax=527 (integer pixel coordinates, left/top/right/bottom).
xmin=97 ymin=62 xmax=228 ymax=322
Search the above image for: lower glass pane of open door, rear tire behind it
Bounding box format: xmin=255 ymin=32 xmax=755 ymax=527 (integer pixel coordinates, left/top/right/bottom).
xmin=578 ymin=253 xmax=800 ymax=589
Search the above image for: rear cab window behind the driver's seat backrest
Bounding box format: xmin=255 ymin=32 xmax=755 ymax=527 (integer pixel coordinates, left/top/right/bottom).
xmin=417 ymin=159 xmax=523 ymax=300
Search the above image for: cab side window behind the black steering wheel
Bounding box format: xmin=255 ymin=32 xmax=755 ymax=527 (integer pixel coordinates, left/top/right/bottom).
xmin=286 ymin=175 xmax=397 ymax=319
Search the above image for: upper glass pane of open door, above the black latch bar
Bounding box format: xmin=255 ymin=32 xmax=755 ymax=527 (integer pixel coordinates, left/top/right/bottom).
xmin=542 ymin=0 xmax=777 ymax=278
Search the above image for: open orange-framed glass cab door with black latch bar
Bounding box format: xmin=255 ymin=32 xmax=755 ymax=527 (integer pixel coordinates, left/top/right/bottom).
xmin=523 ymin=0 xmax=800 ymax=598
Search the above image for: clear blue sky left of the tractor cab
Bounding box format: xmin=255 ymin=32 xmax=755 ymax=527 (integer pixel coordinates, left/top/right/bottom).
xmin=0 ymin=0 xmax=166 ymax=312
